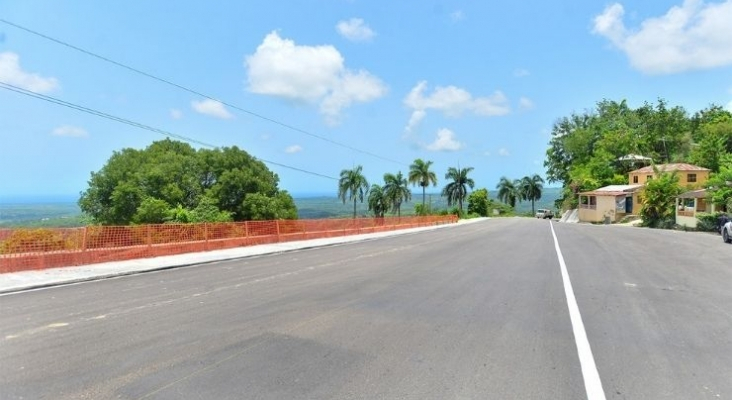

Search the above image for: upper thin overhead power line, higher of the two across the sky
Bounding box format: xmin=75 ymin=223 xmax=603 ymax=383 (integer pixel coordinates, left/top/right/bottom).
xmin=0 ymin=18 xmax=406 ymax=165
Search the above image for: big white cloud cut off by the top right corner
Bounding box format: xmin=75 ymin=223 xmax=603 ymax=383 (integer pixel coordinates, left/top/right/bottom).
xmin=593 ymin=0 xmax=732 ymax=74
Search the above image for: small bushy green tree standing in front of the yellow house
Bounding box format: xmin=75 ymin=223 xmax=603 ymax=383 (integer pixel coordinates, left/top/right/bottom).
xmin=640 ymin=170 xmax=682 ymax=228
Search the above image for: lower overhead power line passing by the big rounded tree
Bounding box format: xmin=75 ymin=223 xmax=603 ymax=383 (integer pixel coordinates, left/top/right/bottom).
xmin=0 ymin=81 xmax=338 ymax=180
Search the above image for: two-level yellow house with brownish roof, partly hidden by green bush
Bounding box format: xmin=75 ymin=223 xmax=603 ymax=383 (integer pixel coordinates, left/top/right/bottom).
xmin=578 ymin=163 xmax=710 ymax=222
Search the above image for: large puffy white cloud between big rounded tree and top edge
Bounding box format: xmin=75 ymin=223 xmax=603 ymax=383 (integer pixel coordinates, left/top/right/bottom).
xmin=244 ymin=32 xmax=387 ymax=123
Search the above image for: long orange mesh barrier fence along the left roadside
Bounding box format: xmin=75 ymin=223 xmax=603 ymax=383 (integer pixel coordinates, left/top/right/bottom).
xmin=0 ymin=215 xmax=457 ymax=273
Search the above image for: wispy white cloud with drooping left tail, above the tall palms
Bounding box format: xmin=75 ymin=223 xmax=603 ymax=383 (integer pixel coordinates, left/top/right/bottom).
xmin=404 ymin=81 xmax=511 ymax=132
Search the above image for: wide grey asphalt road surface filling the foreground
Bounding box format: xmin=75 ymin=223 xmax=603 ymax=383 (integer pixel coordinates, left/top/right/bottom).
xmin=0 ymin=219 xmax=732 ymax=399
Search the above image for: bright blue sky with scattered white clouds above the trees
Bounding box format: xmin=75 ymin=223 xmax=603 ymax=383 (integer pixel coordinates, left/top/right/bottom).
xmin=0 ymin=0 xmax=732 ymax=197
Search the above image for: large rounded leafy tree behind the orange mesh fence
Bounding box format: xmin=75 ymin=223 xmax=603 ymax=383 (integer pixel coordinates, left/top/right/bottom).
xmin=79 ymin=139 xmax=297 ymax=225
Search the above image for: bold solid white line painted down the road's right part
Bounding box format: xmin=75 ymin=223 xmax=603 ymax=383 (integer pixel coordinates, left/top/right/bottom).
xmin=549 ymin=222 xmax=605 ymax=400
